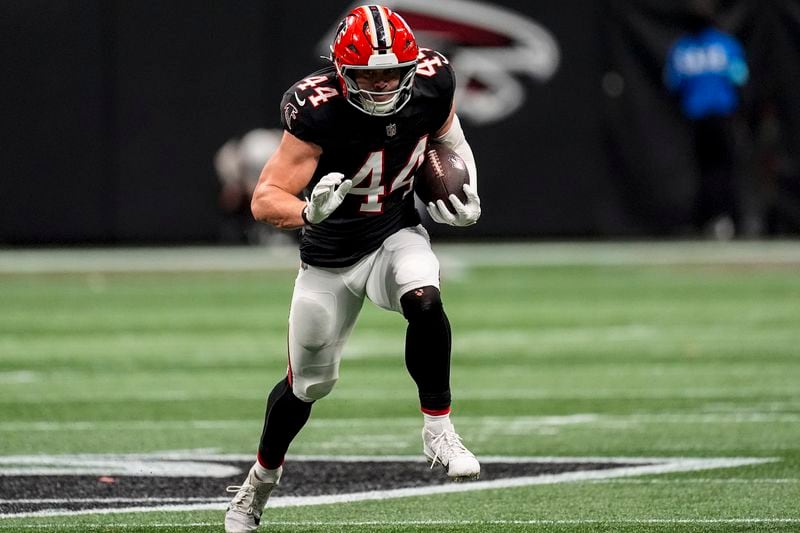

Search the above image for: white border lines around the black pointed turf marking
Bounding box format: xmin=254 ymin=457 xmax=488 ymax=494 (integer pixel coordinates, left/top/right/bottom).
xmin=0 ymin=451 xmax=779 ymax=518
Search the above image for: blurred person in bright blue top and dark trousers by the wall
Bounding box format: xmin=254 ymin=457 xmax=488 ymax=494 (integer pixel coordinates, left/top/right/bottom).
xmin=664 ymin=0 xmax=753 ymax=239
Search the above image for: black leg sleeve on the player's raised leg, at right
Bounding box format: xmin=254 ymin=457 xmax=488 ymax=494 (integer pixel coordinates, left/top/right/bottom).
xmin=400 ymin=286 xmax=451 ymax=411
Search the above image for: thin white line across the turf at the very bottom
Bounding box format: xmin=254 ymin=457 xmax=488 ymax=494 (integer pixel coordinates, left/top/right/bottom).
xmin=0 ymin=517 xmax=800 ymax=529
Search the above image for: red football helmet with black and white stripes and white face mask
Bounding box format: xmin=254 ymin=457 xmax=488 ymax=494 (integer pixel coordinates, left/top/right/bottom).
xmin=331 ymin=4 xmax=419 ymax=116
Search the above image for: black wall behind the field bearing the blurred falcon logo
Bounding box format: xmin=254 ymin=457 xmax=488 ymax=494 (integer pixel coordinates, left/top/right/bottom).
xmin=0 ymin=0 xmax=800 ymax=245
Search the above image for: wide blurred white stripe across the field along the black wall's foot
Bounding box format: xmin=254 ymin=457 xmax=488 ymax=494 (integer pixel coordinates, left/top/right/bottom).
xmin=0 ymin=241 xmax=800 ymax=274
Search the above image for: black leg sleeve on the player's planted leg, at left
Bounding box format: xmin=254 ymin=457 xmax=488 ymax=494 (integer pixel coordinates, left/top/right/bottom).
xmin=258 ymin=378 xmax=313 ymax=468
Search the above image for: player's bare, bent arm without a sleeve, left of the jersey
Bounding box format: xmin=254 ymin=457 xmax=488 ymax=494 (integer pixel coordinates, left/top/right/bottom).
xmin=250 ymin=131 xmax=322 ymax=229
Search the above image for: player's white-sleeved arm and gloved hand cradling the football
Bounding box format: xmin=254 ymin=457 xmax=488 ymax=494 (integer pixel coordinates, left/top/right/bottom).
xmin=428 ymin=104 xmax=481 ymax=226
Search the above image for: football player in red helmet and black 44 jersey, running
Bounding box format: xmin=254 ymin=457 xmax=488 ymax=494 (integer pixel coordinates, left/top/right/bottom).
xmin=225 ymin=5 xmax=481 ymax=533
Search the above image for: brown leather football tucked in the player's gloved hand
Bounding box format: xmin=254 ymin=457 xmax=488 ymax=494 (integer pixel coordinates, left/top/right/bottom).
xmin=414 ymin=143 xmax=469 ymax=206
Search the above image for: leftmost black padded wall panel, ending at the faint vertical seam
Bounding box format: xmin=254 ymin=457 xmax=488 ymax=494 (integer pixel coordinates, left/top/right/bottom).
xmin=0 ymin=0 xmax=115 ymax=242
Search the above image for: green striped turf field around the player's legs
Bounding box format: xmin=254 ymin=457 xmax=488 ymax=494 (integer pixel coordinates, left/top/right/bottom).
xmin=0 ymin=242 xmax=800 ymax=532
